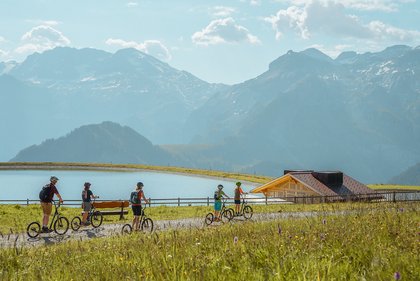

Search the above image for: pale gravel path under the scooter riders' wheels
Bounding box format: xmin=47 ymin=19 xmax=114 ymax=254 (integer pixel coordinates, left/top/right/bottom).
xmin=0 ymin=212 xmax=325 ymax=248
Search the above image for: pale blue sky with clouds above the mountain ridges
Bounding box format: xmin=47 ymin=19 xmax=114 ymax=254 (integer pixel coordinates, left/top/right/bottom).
xmin=0 ymin=0 xmax=420 ymax=84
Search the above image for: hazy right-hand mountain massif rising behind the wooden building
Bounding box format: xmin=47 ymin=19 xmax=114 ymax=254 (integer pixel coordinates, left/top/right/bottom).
xmin=188 ymin=46 xmax=420 ymax=183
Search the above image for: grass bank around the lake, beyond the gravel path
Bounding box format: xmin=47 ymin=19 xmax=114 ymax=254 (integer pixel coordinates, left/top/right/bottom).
xmin=0 ymin=162 xmax=420 ymax=233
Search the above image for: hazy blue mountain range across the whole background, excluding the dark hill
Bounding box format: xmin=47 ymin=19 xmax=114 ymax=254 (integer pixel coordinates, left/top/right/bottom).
xmin=0 ymin=46 xmax=420 ymax=183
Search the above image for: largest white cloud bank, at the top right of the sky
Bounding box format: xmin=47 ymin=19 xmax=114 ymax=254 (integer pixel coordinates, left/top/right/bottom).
xmin=265 ymin=0 xmax=420 ymax=42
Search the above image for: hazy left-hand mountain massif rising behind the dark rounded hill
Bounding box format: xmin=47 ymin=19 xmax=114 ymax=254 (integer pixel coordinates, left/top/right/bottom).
xmin=0 ymin=47 xmax=227 ymax=161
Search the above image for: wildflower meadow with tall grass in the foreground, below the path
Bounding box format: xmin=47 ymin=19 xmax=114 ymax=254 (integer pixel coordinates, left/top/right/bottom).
xmin=0 ymin=202 xmax=420 ymax=280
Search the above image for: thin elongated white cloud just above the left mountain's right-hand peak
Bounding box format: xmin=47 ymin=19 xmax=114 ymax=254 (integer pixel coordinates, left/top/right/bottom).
xmin=105 ymin=38 xmax=172 ymax=61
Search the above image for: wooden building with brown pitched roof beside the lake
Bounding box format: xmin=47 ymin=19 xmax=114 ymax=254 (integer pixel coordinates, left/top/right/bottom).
xmin=251 ymin=170 xmax=373 ymax=198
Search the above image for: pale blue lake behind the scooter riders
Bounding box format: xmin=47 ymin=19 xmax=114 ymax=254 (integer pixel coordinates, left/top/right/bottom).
xmin=0 ymin=170 xmax=257 ymax=201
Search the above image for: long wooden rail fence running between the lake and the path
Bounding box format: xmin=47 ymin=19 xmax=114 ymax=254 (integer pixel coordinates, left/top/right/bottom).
xmin=0 ymin=191 xmax=420 ymax=206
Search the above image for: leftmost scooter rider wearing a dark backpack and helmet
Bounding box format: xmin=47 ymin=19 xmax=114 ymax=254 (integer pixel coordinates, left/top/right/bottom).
xmin=39 ymin=176 xmax=63 ymax=233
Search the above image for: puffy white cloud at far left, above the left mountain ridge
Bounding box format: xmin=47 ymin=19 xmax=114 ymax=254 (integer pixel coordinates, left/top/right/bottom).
xmin=15 ymin=25 xmax=70 ymax=54
